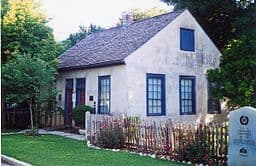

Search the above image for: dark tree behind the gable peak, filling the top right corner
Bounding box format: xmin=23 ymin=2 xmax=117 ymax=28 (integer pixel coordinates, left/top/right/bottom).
xmin=162 ymin=0 xmax=256 ymax=50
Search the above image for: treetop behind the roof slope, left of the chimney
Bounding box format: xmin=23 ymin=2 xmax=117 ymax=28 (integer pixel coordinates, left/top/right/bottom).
xmin=61 ymin=24 xmax=104 ymax=50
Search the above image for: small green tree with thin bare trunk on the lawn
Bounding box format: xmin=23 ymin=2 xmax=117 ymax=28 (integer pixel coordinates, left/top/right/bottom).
xmin=2 ymin=55 xmax=56 ymax=129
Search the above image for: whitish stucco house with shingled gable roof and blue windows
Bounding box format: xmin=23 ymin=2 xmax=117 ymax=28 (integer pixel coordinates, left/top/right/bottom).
xmin=57 ymin=9 xmax=224 ymax=124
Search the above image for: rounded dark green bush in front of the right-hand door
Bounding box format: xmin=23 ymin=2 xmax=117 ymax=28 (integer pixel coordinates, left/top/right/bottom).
xmin=72 ymin=105 xmax=93 ymax=128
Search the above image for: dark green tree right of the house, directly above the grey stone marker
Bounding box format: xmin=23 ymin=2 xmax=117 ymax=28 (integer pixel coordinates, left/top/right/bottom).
xmin=207 ymin=33 xmax=256 ymax=108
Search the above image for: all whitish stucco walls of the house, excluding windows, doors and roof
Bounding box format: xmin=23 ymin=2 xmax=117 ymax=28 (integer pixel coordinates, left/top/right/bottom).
xmin=57 ymin=10 xmax=225 ymax=122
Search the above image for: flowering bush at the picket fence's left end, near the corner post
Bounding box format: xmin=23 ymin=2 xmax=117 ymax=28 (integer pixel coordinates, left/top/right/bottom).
xmin=96 ymin=122 xmax=125 ymax=149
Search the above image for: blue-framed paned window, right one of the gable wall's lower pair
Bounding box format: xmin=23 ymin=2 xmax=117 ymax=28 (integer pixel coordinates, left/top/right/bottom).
xmin=180 ymin=76 xmax=196 ymax=115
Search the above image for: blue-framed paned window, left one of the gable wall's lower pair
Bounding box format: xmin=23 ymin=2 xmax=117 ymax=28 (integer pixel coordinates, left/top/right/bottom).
xmin=147 ymin=74 xmax=165 ymax=116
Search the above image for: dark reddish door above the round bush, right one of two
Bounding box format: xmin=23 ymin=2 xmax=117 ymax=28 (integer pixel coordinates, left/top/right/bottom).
xmin=76 ymin=78 xmax=85 ymax=105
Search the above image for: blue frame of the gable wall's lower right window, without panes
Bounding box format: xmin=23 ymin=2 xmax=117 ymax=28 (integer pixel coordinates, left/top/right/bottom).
xmin=179 ymin=75 xmax=196 ymax=115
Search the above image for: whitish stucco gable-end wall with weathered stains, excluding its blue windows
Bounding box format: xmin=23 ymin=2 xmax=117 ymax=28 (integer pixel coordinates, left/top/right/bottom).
xmin=125 ymin=10 xmax=221 ymax=122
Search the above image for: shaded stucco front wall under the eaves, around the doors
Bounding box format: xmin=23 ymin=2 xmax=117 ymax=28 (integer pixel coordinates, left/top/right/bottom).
xmin=57 ymin=65 xmax=127 ymax=119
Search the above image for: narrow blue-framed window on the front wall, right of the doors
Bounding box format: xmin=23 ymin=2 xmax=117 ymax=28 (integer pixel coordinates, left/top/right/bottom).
xmin=98 ymin=76 xmax=110 ymax=114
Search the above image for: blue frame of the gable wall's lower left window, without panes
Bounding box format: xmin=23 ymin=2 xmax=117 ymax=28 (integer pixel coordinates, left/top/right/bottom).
xmin=146 ymin=73 xmax=166 ymax=116
